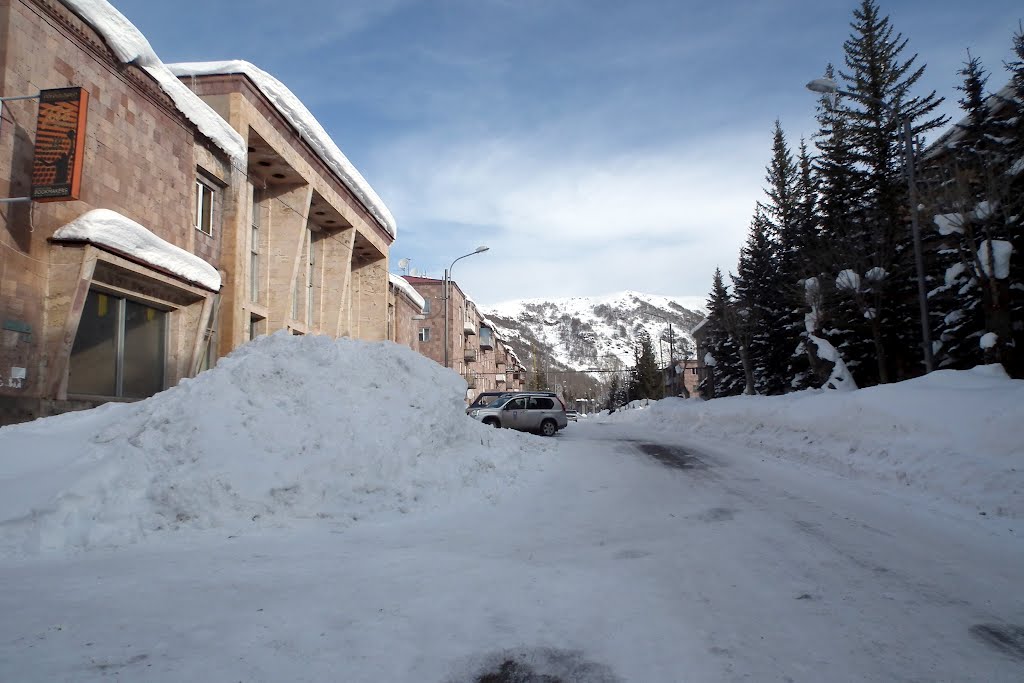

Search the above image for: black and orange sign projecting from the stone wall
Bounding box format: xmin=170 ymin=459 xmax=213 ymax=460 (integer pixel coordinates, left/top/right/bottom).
xmin=32 ymin=87 xmax=89 ymax=202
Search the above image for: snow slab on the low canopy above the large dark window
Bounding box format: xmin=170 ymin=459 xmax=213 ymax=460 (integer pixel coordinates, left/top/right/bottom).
xmin=53 ymin=209 xmax=220 ymax=292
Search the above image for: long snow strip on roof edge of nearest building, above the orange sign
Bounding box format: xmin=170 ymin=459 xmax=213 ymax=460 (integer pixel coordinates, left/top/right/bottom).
xmin=61 ymin=0 xmax=246 ymax=165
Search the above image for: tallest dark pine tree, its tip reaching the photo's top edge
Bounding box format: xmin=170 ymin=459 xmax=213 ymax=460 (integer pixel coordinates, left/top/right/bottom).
xmin=835 ymin=0 xmax=945 ymax=386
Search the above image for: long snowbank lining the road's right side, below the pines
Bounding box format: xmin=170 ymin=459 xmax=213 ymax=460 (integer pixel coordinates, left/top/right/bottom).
xmin=598 ymin=365 xmax=1024 ymax=518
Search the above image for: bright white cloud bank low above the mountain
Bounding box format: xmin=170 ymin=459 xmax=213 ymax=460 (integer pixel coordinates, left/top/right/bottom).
xmin=381 ymin=126 xmax=770 ymax=302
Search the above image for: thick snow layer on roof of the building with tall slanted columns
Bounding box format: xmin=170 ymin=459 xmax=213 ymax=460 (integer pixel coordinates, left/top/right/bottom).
xmin=168 ymin=59 xmax=397 ymax=238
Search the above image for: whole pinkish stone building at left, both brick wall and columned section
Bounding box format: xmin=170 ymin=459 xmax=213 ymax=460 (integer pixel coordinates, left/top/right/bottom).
xmin=0 ymin=0 xmax=394 ymax=425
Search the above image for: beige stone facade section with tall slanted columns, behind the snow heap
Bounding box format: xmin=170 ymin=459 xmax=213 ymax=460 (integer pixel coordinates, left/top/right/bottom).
xmin=165 ymin=61 xmax=394 ymax=354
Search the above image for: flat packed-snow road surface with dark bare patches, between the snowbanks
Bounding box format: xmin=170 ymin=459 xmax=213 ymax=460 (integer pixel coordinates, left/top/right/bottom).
xmin=0 ymin=421 xmax=1024 ymax=683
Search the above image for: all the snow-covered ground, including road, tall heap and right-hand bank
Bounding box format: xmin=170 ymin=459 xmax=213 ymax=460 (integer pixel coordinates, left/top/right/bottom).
xmin=0 ymin=334 xmax=1024 ymax=683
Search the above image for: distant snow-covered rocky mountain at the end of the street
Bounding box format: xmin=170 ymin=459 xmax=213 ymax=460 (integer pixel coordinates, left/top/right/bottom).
xmin=481 ymin=291 xmax=703 ymax=371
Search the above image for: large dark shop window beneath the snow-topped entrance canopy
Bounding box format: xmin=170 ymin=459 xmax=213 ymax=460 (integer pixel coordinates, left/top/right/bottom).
xmin=68 ymin=290 xmax=167 ymax=398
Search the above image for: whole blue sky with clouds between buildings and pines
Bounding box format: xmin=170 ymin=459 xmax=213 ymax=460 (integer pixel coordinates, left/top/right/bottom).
xmin=114 ymin=0 xmax=1024 ymax=306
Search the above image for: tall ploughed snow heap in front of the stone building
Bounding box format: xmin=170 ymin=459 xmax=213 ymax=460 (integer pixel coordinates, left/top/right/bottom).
xmin=0 ymin=332 xmax=556 ymax=554
